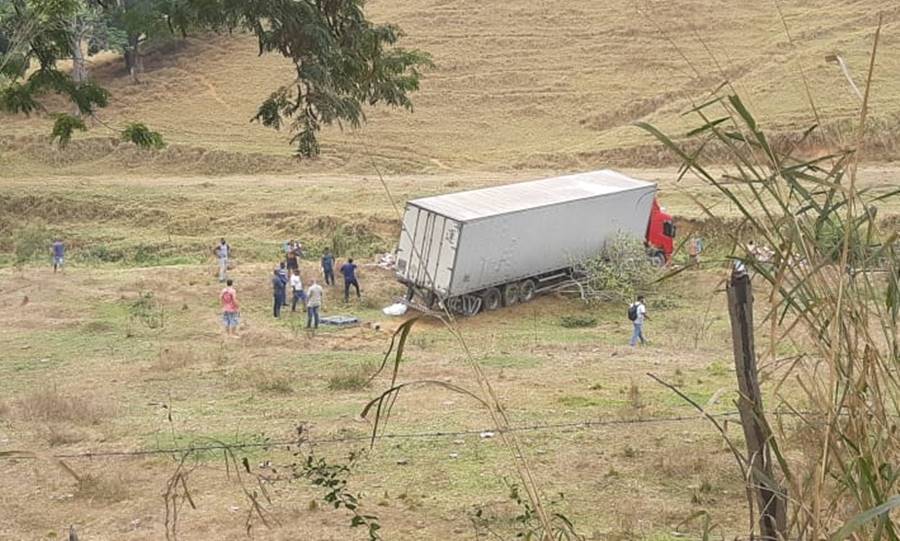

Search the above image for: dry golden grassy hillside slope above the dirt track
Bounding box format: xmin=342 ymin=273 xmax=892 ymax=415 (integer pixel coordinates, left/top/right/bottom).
xmin=0 ymin=0 xmax=900 ymax=174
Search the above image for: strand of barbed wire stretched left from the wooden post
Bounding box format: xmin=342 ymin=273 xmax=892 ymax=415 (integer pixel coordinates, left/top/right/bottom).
xmin=0 ymin=411 xmax=739 ymax=460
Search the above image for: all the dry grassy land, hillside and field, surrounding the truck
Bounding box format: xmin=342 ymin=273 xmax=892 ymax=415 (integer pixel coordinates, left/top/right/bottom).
xmin=0 ymin=0 xmax=900 ymax=541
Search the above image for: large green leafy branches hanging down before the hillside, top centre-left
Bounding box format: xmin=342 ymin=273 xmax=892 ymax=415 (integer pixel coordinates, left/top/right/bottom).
xmin=166 ymin=0 xmax=431 ymax=157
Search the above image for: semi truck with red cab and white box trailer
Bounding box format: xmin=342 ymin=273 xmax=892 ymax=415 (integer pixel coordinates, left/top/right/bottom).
xmin=396 ymin=170 xmax=675 ymax=316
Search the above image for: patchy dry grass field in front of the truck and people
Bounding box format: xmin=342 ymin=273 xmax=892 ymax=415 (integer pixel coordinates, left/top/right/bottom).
xmin=0 ymin=253 xmax=744 ymax=540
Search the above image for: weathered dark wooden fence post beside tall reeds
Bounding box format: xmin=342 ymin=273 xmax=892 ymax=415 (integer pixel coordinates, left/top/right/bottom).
xmin=727 ymin=265 xmax=786 ymax=541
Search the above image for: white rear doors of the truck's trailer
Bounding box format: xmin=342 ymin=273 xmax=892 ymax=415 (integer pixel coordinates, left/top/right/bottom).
xmin=397 ymin=205 xmax=460 ymax=295
